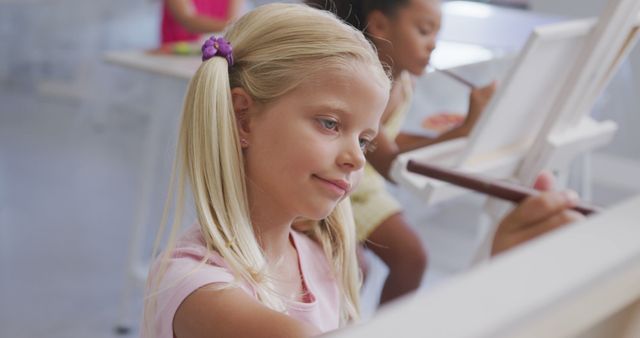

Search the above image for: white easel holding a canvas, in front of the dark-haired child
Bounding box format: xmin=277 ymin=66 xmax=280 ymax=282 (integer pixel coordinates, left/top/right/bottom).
xmin=391 ymin=0 xmax=640 ymax=209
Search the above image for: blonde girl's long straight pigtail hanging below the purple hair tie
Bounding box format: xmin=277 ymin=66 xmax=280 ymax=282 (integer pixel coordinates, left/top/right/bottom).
xmin=180 ymin=57 xmax=285 ymax=311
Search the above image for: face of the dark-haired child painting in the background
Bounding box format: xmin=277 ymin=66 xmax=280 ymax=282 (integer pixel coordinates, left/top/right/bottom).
xmin=385 ymin=0 xmax=441 ymax=75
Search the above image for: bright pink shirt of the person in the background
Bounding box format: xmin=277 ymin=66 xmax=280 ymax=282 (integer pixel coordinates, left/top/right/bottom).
xmin=160 ymin=0 xmax=229 ymax=44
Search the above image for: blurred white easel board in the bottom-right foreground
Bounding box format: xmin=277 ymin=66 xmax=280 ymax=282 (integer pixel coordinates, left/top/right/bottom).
xmin=333 ymin=196 xmax=640 ymax=338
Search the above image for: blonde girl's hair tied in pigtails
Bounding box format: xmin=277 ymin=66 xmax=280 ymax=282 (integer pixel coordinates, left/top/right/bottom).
xmin=145 ymin=4 xmax=390 ymax=327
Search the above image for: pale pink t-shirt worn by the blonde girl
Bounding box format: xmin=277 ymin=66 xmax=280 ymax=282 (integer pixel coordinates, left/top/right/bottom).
xmin=142 ymin=225 xmax=340 ymax=338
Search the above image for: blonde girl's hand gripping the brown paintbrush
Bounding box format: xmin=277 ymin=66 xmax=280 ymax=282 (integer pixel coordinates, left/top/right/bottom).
xmin=491 ymin=172 xmax=584 ymax=255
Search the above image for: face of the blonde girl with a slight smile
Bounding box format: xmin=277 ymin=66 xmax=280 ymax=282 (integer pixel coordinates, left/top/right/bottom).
xmin=241 ymin=63 xmax=388 ymax=221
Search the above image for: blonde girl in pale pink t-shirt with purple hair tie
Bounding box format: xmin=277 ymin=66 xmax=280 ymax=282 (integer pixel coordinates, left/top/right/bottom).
xmin=142 ymin=4 xmax=584 ymax=338
